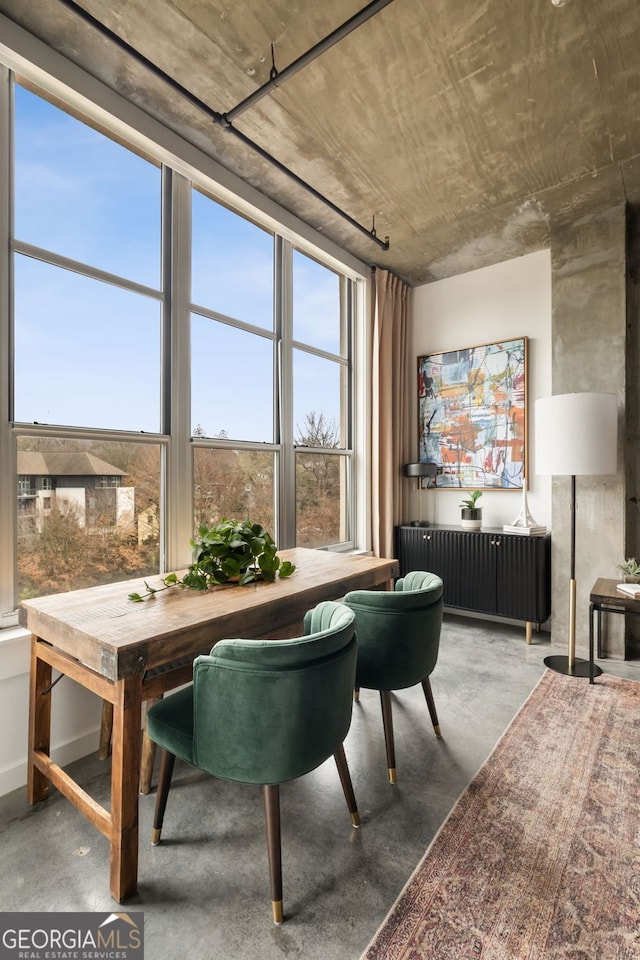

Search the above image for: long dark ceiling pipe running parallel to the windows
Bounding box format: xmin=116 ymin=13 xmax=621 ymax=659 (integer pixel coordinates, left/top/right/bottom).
xmin=52 ymin=0 xmax=393 ymax=250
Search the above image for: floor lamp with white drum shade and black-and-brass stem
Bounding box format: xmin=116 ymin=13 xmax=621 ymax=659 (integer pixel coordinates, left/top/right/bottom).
xmin=535 ymin=393 xmax=618 ymax=677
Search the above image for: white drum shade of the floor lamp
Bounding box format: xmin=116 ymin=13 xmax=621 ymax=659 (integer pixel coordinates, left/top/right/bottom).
xmin=535 ymin=393 xmax=618 ymax=476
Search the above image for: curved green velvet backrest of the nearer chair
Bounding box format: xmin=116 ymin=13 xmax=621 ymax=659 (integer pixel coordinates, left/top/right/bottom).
xmin=193 ymin=601 xmax=356 ymax=784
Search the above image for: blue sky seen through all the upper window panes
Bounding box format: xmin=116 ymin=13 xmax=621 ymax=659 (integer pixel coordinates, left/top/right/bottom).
xmin=15 ymin=87 xmax=339 ymax=441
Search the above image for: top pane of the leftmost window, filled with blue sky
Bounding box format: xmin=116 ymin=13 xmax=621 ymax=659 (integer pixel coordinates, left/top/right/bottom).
xmin=14 ymin=84 xmax=161 ymax=289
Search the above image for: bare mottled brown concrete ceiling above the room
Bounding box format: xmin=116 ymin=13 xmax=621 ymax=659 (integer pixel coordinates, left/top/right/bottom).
xmin=0 ymin=0 xmax=640 ymax=284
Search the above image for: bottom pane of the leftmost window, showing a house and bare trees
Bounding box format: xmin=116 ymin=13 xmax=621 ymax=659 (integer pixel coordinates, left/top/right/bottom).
xmin=17 ymin=435 xmax=160 ymax=599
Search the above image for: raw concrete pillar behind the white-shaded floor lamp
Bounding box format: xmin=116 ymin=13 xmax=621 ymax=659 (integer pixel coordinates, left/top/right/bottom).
xmin=551 ymin=204 xmax=637 ymax=657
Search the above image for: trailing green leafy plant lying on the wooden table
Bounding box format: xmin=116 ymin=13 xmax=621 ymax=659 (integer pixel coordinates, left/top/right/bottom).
xmin=129 ymin=520 xmax=296 ymax=603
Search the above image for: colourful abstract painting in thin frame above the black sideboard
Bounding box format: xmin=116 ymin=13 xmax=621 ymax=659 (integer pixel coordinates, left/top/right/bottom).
xmin=418 ymin=337 xmax=527 ymax=490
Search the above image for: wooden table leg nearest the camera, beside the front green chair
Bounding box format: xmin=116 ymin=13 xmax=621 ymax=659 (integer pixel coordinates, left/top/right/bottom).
xmin=110 ymin=676 xmax=142 ymax=902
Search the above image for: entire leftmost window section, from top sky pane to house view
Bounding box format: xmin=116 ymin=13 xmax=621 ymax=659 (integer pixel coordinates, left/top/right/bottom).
xmin=10 ymin=84 xmax=162 ymax=599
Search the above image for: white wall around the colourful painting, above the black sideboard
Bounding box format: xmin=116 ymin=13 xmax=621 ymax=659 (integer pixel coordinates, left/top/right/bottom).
xmin=407 ymin=250 xmax=551 ymax=529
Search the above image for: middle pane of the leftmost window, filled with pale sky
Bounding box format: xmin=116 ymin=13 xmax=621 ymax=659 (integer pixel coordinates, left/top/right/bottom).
xmin=14 ymin=258 xmax=161 ymax=433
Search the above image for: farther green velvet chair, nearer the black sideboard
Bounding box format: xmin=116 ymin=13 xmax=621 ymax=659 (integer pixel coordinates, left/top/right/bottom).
xmin=344 ymin=570 xmax=442 ymax=783
